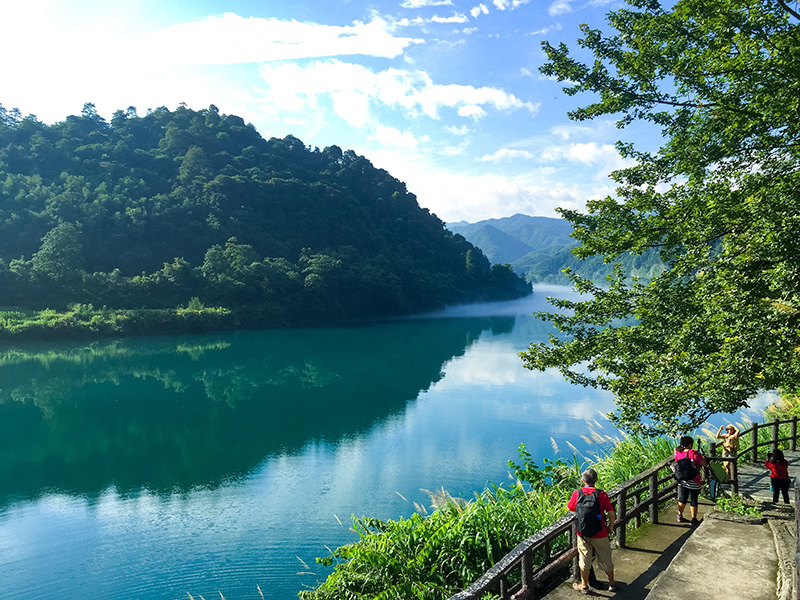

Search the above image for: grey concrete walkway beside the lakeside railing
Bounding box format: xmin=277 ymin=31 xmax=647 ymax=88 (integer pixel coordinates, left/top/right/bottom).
xmin=547 ymin=452 xmax=800 ymax=600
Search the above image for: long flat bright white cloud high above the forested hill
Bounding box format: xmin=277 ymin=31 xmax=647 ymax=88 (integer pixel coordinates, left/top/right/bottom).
xmin=140 ymin=13 xmax=422 ymax=65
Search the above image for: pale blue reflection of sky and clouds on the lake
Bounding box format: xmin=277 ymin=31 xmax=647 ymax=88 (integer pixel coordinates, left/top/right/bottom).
xmin=0 ymin=288 xmax=788 ymax=600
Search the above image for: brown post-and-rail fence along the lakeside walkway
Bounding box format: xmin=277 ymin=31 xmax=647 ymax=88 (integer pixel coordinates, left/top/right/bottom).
xmin=449 ymin=417 xmax=800 ymax=600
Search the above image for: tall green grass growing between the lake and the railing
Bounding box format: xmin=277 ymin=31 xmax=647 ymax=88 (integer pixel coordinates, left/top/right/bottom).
xmin=299 ymin=438 xmax=674 ymax=600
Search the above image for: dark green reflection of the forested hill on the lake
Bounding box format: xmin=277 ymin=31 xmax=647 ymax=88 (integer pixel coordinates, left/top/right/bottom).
xmin=0 ymin=319 xmax=513 ymax=503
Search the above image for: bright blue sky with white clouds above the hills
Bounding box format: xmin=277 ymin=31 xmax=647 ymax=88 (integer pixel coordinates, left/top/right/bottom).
xmin=0 ymin=0 xmax=633 ymax=221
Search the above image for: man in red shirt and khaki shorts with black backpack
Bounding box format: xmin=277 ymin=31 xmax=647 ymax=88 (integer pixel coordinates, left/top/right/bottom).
xmin=567 ymin=469 xmax=617 ymax=594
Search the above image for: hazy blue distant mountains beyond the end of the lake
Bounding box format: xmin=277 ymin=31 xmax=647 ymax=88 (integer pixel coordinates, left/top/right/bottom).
xmin=447 ymin=214 xmax=663 ymax=285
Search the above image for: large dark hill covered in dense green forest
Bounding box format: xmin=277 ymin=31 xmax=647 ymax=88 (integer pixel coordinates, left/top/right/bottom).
xmin=0 ymin=99 xmax=530 ymax=327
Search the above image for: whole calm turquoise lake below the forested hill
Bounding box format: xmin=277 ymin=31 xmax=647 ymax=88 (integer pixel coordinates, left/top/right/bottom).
xmin=0 ymin=287 xmax=768 ymax=600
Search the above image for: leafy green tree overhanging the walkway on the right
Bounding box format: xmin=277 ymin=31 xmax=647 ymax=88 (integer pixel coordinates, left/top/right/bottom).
xmin=522 ymin=0 xmax=800 ymax=432
